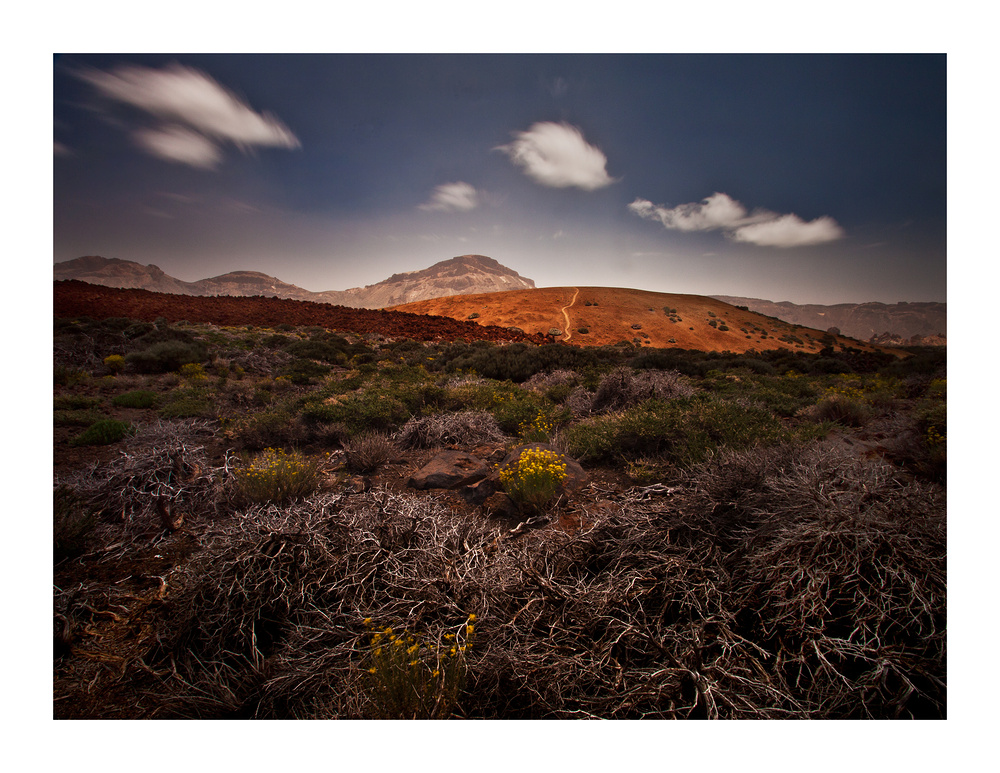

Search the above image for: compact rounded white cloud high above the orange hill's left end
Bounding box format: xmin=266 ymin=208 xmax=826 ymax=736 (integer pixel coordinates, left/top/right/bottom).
xmin=494 ymin=122 xmax=615 ymax=191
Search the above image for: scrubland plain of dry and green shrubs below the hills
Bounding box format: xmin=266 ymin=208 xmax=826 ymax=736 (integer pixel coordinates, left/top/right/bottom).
xmin=53 ymin=308 xmax=948 ymax=719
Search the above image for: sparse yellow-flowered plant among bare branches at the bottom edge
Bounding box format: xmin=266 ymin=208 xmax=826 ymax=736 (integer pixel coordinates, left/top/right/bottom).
xmin=362 ymin=615 xmax=476 ymax=719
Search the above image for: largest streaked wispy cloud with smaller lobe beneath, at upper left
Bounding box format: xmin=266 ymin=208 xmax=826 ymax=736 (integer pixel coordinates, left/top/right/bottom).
xmin=77 ymin=64 xmax=301 ymax=169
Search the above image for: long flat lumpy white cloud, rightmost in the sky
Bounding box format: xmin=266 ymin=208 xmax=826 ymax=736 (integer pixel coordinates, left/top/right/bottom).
xmin=628 ymin=193 xmax=844 ymax=247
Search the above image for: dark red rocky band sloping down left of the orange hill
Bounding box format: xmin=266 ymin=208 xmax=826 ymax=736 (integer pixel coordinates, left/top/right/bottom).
xmin=53 ymin=280 xmax=551 ymax=344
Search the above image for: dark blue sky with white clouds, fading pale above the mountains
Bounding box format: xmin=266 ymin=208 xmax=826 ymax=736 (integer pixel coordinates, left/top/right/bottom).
xmin=53 ymin=54 xmax=947 ymax=303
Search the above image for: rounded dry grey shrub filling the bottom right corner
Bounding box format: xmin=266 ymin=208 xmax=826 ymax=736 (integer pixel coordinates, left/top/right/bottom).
xmin=696 ymin=444 xmax=946 ymax=718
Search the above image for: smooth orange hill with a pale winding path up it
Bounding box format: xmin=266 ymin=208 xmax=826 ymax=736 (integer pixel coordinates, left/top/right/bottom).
xmin=392 ymin=287 xmax=892 ymax=353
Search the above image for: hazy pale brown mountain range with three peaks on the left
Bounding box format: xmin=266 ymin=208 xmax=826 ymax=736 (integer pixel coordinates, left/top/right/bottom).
xmin=54 ymin=255 xmax=535 ymax=309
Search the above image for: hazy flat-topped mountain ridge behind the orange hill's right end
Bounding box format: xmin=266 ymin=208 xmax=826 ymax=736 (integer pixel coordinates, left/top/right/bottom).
xmin=712 ymin=295 xmax=948 ymax=343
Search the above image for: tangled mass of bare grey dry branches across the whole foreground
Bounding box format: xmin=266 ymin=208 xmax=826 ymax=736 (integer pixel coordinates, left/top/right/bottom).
xmin=135 ymin=446 xmax=945 ymax=718
